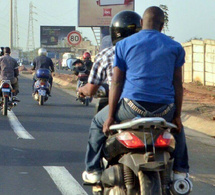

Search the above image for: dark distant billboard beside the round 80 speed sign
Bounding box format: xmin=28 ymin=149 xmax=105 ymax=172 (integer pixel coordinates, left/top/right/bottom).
xmin=40 ymin=26 xmax=75 ymax=48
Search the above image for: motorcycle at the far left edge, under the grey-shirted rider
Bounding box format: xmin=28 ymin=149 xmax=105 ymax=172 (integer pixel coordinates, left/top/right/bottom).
xmin=0 ymin=80 xmax=18 ymax=116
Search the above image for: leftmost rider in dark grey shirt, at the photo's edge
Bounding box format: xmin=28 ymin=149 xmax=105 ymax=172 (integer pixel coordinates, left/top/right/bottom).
xmin=0 ymin=47 xmax=19 ymax=96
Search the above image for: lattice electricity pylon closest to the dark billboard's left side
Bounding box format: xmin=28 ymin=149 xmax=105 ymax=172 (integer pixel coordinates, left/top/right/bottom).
xmin=26 ymin=2 xmax=37 ymax=61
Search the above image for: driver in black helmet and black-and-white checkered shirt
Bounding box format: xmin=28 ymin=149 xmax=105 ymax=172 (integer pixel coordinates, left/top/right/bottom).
xmin=79 ymin=11 xmax=141 ymax=96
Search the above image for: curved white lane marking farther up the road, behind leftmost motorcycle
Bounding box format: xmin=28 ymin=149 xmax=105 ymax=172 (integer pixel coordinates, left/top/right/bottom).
xmin=7 ymin=110 xmax=34 ymax=139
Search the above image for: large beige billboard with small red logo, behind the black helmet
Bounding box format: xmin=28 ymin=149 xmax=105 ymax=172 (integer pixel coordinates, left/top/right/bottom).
xmin=78 ymin=0 xmax=134 ymax=27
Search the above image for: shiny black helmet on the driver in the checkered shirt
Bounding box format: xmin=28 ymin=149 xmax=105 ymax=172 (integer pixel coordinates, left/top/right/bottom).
xmin=110 ymin=11 xmax=142 ymax=45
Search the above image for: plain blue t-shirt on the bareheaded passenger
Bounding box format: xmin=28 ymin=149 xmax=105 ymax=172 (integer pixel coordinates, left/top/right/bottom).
xmin=113 ymin=30 xmax=185 ymax=104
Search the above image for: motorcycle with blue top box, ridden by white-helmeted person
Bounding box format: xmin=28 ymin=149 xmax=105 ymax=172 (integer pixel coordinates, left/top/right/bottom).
xmin=33 ymin=68 xmax=51 ymax=106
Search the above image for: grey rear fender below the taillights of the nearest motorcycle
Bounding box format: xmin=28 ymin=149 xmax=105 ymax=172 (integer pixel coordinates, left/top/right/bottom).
xmin=119 ymin=151 xmax=170 ymax=176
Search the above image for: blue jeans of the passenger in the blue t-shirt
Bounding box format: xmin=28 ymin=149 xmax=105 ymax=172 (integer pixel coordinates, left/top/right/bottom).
xmin=85 ymin=99 xmax=189 ymax=172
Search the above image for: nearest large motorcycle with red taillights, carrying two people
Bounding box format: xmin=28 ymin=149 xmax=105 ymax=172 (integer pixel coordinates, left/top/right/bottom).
xmin=84 ymin=92 xmax=192 ymax=195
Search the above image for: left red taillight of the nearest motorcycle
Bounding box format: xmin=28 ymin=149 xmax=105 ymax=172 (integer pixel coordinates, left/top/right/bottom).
xmin=117 ymin=132 xmax=145 ymax=148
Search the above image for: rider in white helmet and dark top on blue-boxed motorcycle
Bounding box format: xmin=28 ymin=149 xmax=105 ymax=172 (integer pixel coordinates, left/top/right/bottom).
xmin=32 ymin=48 xmax=54 ymax=95
